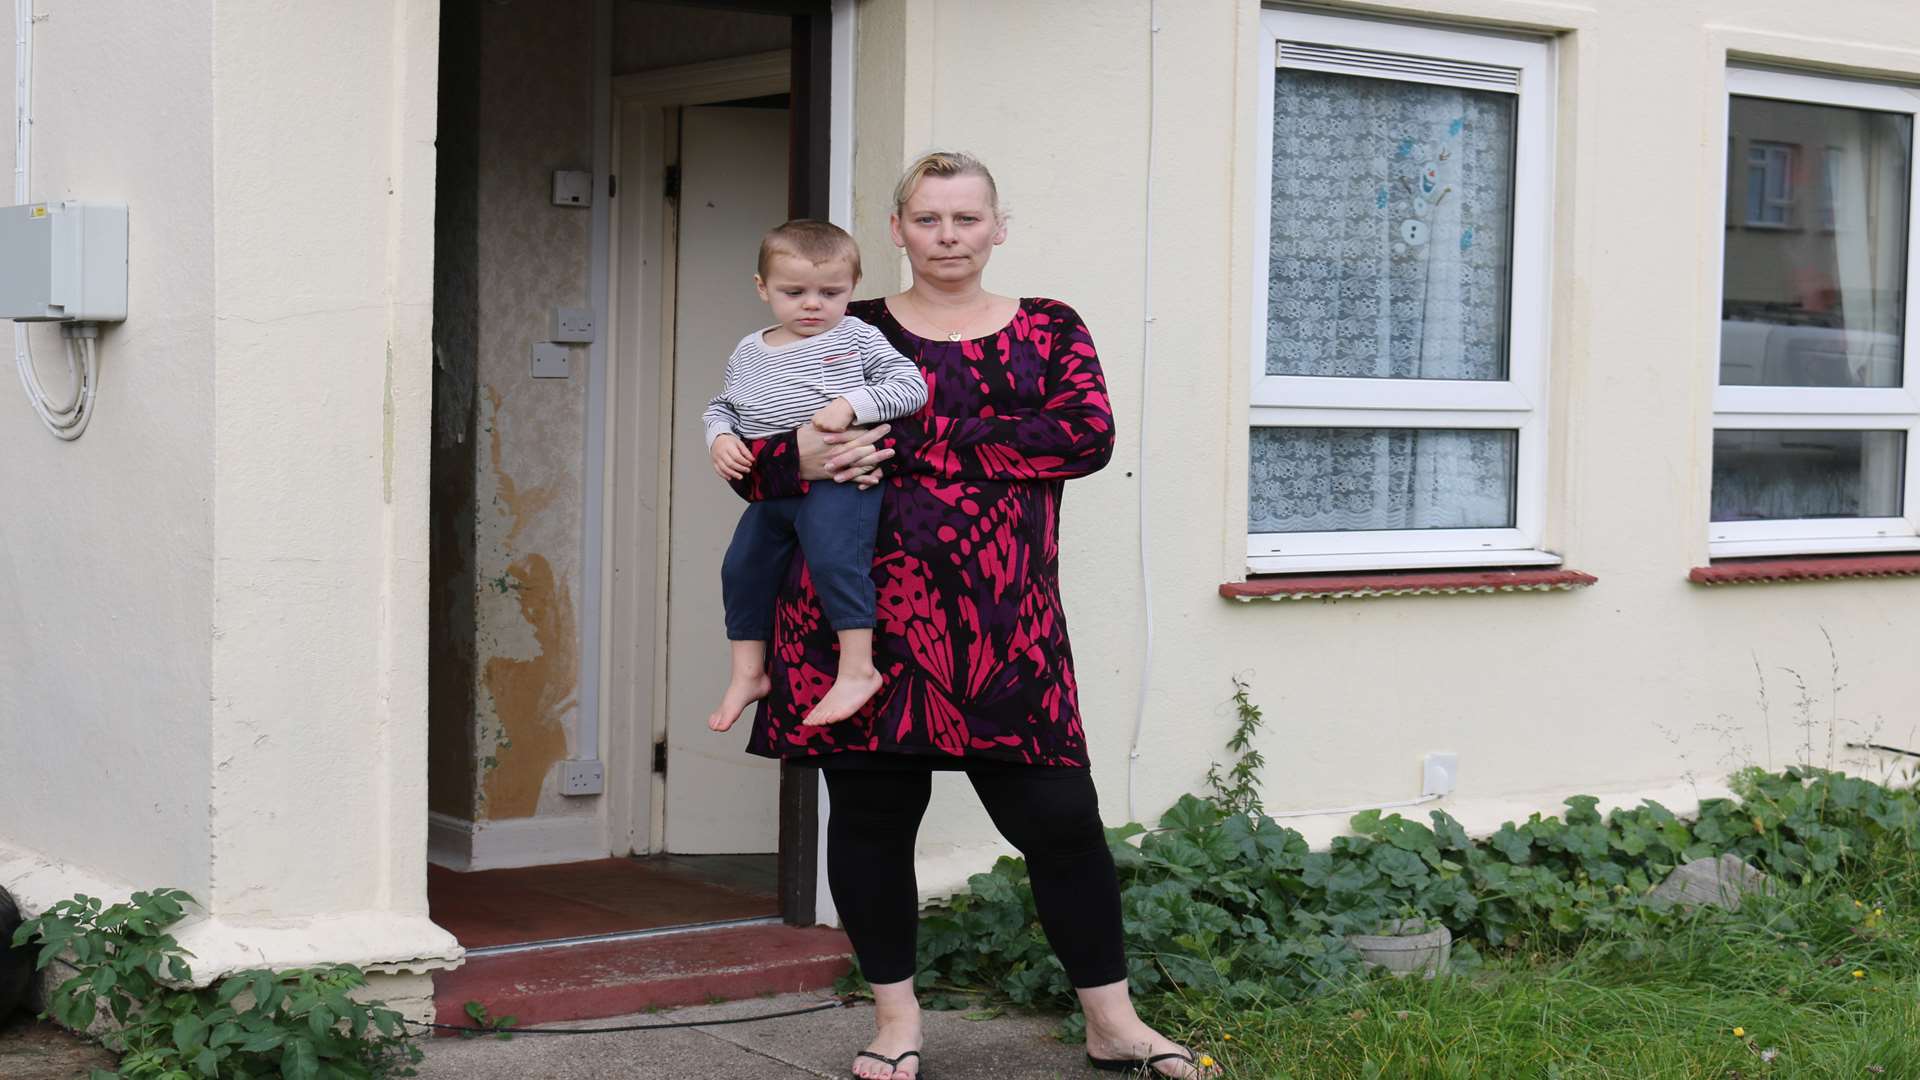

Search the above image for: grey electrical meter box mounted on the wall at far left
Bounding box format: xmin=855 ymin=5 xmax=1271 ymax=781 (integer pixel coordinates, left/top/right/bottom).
xmin=0 ymin=200 xmax=127 ymax=323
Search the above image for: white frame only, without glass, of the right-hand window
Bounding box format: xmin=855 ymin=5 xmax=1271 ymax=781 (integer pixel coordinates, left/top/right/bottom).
xmin=1705 ymin=65 xmax=1920 ymax=559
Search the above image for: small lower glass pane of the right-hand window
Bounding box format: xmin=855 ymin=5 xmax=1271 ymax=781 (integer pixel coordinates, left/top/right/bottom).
xmin=1713 ymin=430 xmax=1907 ymax=521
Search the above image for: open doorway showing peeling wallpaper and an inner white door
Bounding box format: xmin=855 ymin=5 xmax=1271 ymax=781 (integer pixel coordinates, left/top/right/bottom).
xmin=428 ymin=0 xmax=831 ymax=951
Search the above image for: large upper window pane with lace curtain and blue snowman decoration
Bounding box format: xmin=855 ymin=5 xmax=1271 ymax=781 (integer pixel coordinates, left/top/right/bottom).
xmin=1267 ymin=69 xmax=1515 ymax=379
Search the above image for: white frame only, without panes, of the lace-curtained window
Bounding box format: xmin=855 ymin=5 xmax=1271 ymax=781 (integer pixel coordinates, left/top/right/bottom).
xmin=1240 ymin=8 xmax=1561 ymax=573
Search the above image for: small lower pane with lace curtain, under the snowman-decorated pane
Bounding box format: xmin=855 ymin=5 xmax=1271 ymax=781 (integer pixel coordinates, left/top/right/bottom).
xmin=1248 ymin=427 xmax=1519 ymax=532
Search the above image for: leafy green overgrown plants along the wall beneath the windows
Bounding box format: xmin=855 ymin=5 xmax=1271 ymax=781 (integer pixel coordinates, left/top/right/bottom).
xmin=920 ymin=680 xmax=1920 ymax=1009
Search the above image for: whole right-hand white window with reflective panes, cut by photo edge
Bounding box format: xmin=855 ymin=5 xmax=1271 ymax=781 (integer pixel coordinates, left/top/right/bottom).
xmin=1709 ymin=67 xmax=1920 ymax=557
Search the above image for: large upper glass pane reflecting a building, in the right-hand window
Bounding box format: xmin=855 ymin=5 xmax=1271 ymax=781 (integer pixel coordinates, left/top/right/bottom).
xmin=1720 ymin=96 xmax=1912 ymax=386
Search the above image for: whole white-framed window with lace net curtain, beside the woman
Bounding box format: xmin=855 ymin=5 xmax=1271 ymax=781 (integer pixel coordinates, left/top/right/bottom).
xmin=1248 ymin=10 xmax=1559 ymax=573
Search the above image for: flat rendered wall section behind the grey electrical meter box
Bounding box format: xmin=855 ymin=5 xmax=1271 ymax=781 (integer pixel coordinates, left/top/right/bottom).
xmin=0 ymin=0 xmax=215 ymax=899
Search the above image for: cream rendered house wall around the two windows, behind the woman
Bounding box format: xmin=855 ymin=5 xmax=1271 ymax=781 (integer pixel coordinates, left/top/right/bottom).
xmin=854 ymin=0 xmax=1920 ymax=896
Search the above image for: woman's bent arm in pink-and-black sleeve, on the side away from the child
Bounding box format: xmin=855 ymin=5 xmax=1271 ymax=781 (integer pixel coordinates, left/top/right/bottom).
xmin=887 ymin=295 xmax=1114 ymax=480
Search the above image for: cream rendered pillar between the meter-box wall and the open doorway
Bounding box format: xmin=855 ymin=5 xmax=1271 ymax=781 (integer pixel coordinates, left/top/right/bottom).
xmin=199 ymin=0 xmax=459 ymax=978
